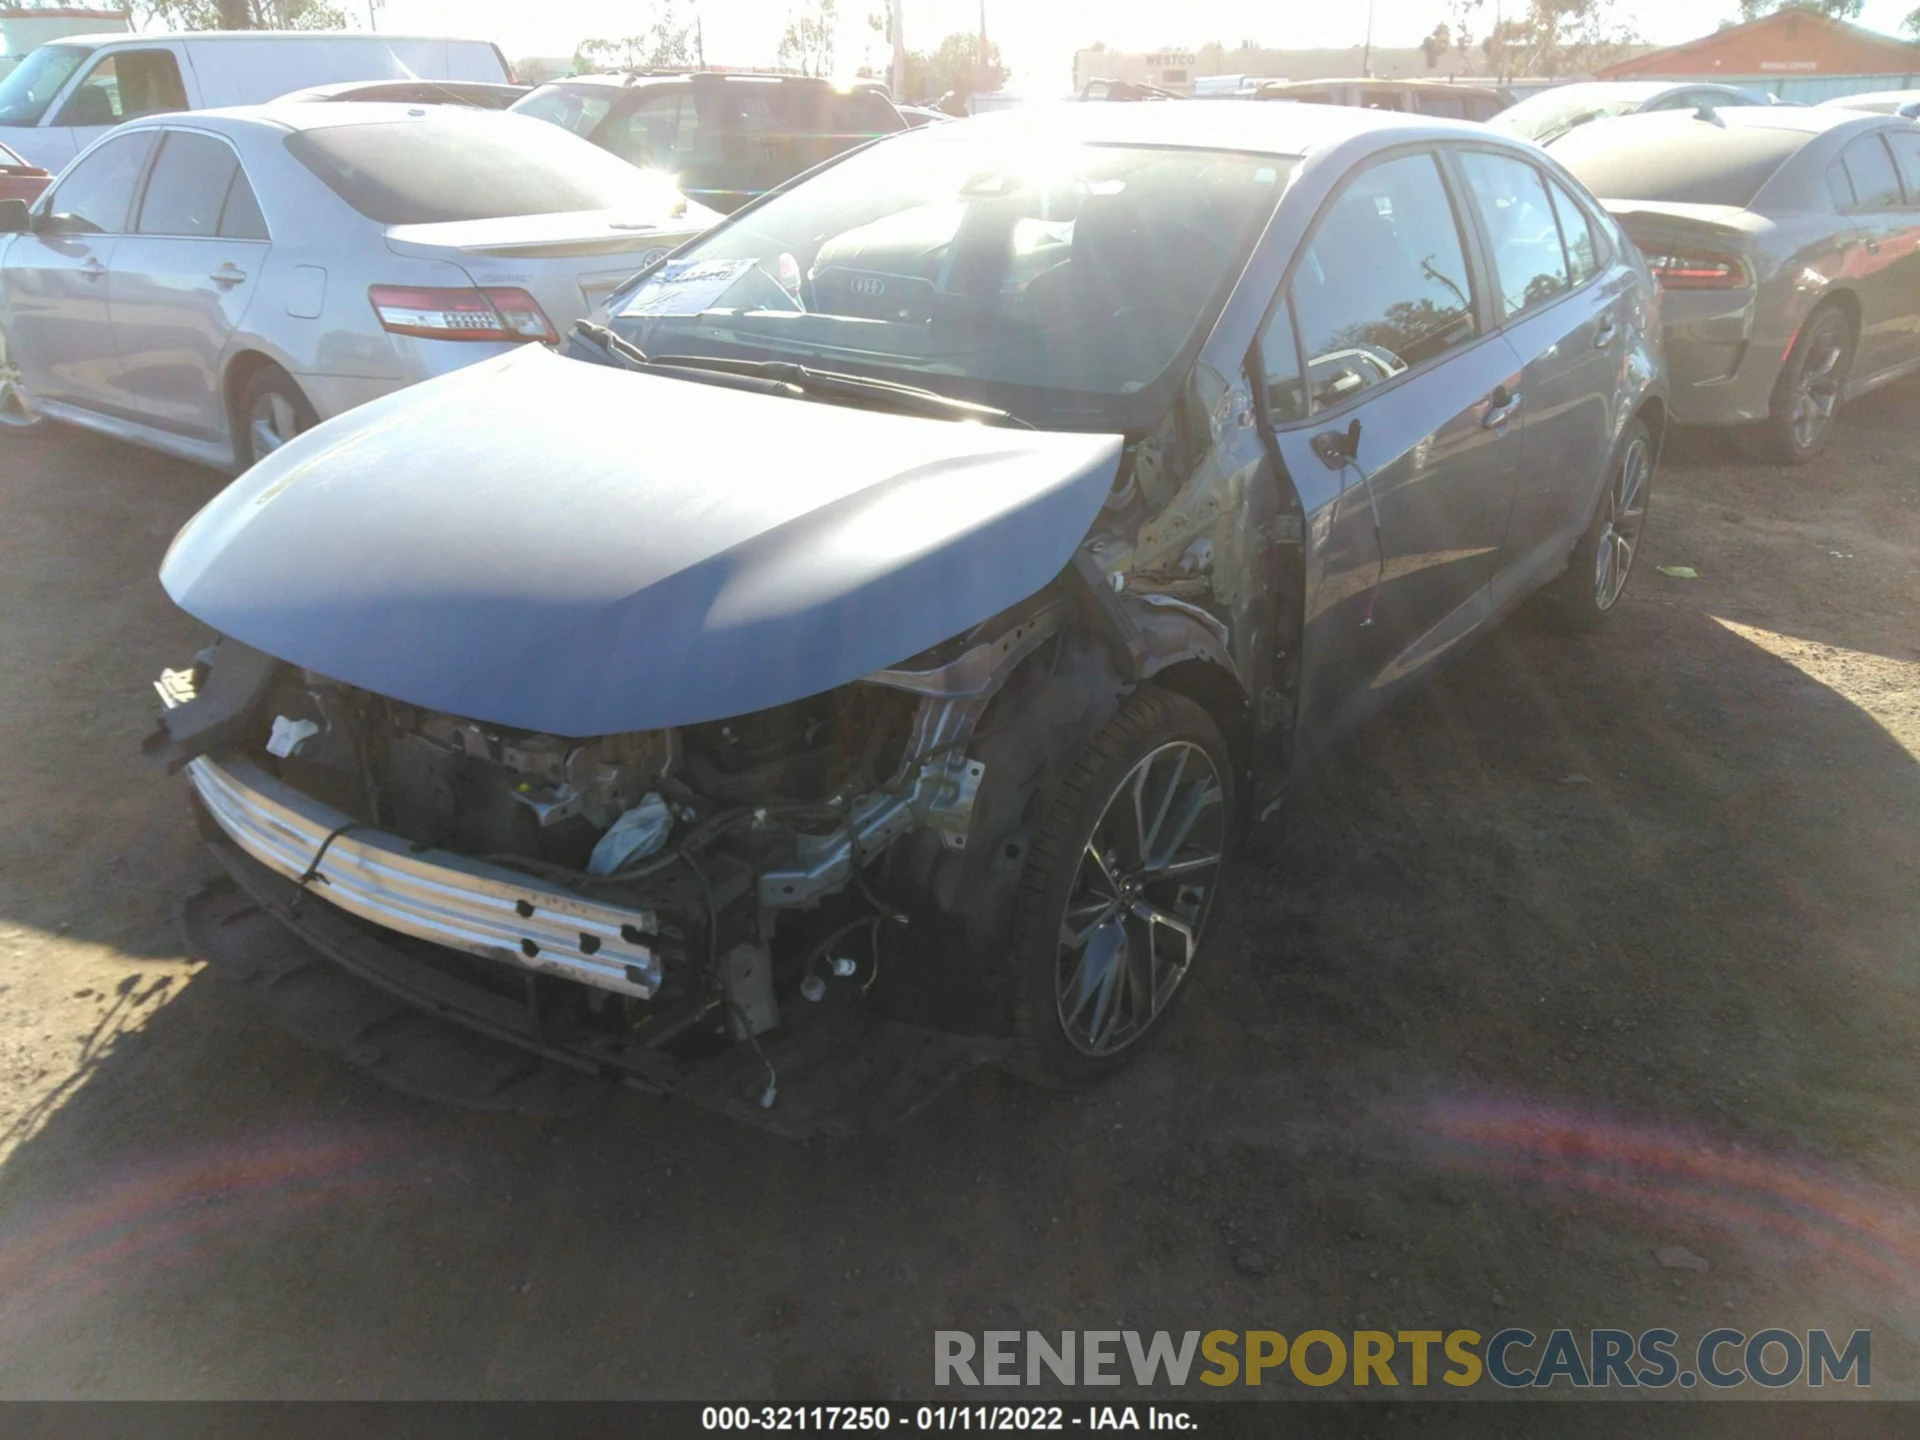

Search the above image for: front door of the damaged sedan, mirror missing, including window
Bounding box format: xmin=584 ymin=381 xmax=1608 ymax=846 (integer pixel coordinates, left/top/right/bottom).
xmin=1261 ymin=150 xmax=1521 ymax=747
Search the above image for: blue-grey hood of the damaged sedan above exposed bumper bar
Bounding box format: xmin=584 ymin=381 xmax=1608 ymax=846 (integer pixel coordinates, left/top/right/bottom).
xmin=159 ymin=346 xmax=1121 ymax=735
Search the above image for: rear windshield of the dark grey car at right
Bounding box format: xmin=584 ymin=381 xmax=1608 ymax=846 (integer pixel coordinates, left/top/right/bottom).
xmin=1553 ymin=117 xmax=1812 ymax=209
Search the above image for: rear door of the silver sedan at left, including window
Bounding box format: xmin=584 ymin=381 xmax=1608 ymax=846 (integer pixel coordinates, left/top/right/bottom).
xmin=108 ymin=129 xmax=269 ymax=438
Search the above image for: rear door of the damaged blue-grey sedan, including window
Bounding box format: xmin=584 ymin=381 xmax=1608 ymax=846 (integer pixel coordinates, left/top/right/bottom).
xmin=1455 ymin=148 xmax=1626 ymax=599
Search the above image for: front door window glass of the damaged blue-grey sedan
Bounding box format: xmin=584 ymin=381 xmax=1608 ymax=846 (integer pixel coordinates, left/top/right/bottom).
xmin=1292 ymin=154 xmax=1476 ymax=411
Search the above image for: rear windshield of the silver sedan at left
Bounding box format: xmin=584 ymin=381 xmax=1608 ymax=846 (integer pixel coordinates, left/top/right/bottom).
xmin=286 ymin=109 xmax=672 ymax=225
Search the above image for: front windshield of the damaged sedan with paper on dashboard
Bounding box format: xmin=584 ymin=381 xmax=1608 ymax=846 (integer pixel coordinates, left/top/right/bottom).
xmin=611 ymin=125 xmax=1294 ymax=426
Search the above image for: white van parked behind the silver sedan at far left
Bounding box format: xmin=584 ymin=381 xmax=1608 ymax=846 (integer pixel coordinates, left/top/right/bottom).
xmin=0 ymin=31 xmax=513 ymax=171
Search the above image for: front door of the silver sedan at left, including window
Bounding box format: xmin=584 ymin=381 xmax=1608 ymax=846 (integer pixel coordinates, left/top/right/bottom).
xmin=4 ymin=131 xmax=154 ymax=411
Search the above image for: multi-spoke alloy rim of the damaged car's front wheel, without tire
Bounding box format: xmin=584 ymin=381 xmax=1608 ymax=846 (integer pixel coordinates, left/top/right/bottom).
xmin=1054 ymin=741 xmax=1227 ymax=1056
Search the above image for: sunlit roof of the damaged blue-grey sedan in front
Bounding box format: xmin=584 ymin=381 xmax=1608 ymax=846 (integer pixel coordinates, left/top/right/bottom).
xmin=939 ymin=102 xmax=1503 ymax=156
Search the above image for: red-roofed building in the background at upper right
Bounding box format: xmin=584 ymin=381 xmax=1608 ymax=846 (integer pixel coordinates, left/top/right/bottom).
xmin=1599 ymin=10 xmax=1920 ymax=104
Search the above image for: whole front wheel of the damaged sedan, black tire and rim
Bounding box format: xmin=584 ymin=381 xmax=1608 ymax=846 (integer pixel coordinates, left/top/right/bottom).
xmin=1006 ymin=687 xmax=1235 ymax=1089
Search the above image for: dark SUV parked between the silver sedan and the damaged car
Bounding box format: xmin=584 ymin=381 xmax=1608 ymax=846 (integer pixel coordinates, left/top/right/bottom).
xmin=513 ymin=71 xmax=908 ymax=213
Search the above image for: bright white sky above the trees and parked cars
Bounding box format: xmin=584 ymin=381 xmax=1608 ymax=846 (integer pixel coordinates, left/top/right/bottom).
xmin=340 ymin=0 xmax=1920 ymax=94
